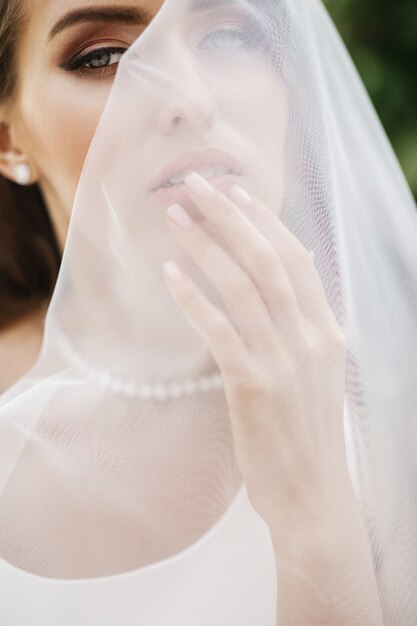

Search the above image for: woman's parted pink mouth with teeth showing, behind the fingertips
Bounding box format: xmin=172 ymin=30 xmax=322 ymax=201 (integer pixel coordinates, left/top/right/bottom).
xmin=151 ymin=146 xmax=243 ymax=219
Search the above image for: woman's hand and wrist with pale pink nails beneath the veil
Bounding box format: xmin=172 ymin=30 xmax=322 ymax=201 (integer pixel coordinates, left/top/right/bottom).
xmin=164 ymin=173 xmax=352 ymax=545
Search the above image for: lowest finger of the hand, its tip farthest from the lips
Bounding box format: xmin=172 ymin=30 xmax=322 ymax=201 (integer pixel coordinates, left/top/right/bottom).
xmin=163 ymin=261 xmax=246 ymax=375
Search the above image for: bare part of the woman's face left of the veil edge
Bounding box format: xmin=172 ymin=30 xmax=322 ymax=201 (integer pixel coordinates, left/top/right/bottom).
xmin=5 ymin=0 xmax=163 ymax=249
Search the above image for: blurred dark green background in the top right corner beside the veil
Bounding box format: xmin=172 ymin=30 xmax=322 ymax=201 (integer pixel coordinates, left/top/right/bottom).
xmin=323 ymin=0 xmax=417 ymax=198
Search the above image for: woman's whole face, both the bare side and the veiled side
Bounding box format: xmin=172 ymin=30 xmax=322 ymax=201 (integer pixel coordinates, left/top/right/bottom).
xmin=3 ymin=0 xmax=287 ymax=251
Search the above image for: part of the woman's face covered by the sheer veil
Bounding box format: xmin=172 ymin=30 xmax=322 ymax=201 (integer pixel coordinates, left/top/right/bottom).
xmin=94 ymin=0 xmax=288 ymax=256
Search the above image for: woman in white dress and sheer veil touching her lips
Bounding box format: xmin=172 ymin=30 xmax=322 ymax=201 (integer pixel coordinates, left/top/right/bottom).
xmin=0 ymin=0 xmax=413 ymax=626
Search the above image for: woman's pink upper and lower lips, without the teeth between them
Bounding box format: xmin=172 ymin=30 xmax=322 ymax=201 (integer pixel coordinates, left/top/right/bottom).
xmin=150 ymin=146 xmax=243 ymax=209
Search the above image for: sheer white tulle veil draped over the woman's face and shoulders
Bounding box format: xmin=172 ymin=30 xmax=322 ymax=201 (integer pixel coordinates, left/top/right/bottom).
xmin=0 ymin=0 xmax=417 ymax=626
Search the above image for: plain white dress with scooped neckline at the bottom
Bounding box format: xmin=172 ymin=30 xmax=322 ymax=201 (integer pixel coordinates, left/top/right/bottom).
xmin=0 ymin=485 xmax=277 ymax=626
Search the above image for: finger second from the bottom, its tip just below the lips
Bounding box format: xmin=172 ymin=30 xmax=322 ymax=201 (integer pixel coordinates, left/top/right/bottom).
xmin=164 ymin=204 xmax=276 ymax=348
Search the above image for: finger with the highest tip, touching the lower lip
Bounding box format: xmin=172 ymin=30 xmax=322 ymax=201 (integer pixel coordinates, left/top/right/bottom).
xmin=185 ymin=173 xmax=301 ymax=329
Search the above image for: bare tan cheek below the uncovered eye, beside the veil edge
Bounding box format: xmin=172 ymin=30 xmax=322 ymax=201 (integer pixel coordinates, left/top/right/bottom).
xmin=22 ymin=78 xmax=111 ymax=192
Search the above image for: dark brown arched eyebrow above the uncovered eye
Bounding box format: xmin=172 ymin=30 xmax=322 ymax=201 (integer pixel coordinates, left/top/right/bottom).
xmin=48 ymin=6 xmax=154 ymax=41
